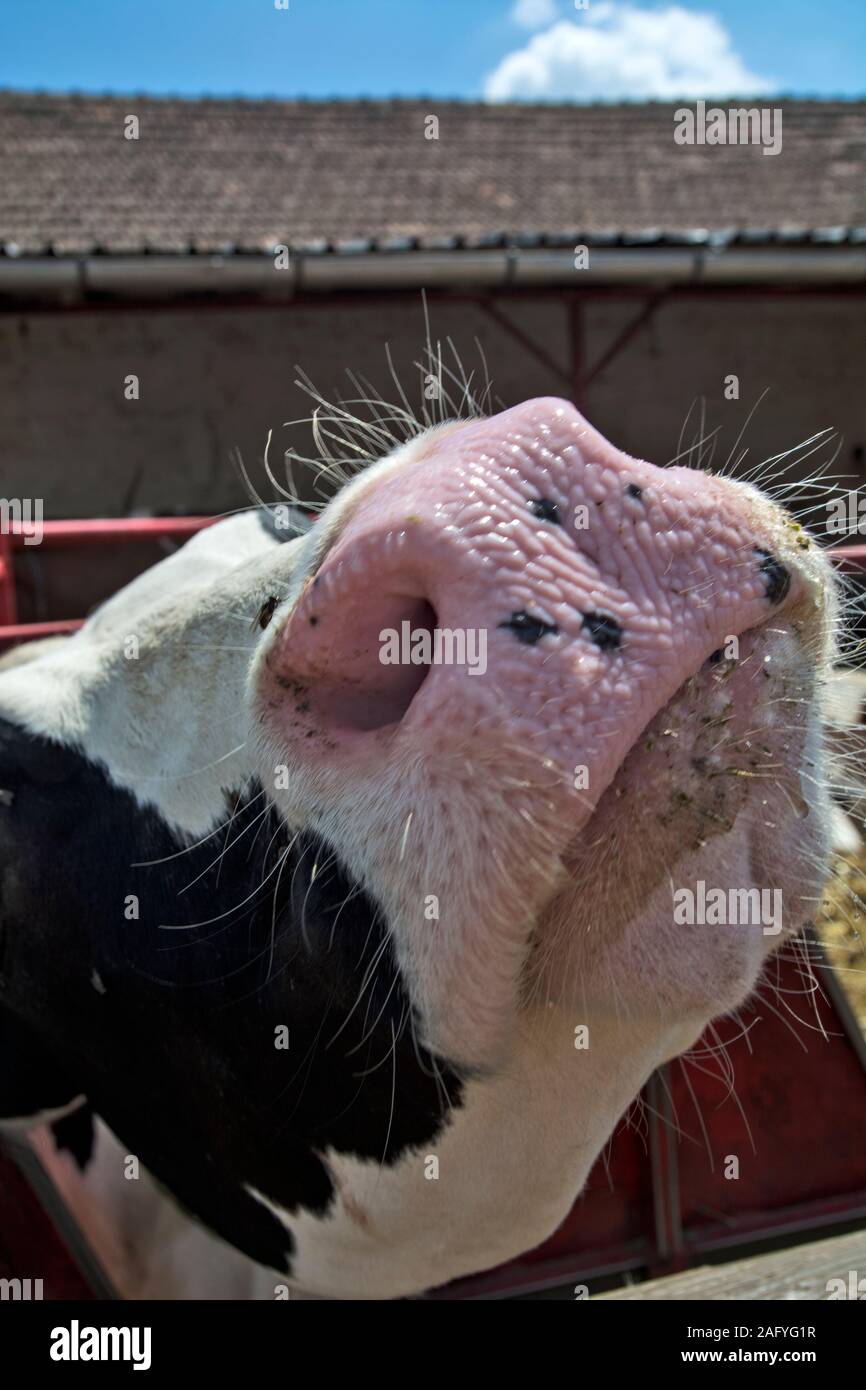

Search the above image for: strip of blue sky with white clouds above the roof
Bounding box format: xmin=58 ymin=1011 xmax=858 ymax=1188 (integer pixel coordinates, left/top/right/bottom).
xmin=0 ymin=0 xmax=866 ymax=100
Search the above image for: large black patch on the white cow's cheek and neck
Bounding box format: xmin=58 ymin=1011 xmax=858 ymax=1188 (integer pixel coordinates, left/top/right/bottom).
xmin=0 ymin=720 xmax=461 ymax=1270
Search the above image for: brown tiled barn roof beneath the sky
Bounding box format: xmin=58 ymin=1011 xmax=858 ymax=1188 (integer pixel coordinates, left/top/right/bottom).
xmin=0 ymin=92 xmax=866 ymax=256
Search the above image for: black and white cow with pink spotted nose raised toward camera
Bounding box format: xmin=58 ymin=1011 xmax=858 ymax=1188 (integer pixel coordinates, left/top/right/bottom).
xmin=0 ymin=399 xmax=835 ymax=1298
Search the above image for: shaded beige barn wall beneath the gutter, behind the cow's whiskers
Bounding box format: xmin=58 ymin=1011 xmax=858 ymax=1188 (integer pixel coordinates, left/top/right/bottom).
xmin=0 ymin=293 xmax=866 ymax=607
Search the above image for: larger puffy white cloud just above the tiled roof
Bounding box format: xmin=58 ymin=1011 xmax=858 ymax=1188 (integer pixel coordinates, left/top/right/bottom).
xmin=484 ymin=0 xmax=776 ymax=101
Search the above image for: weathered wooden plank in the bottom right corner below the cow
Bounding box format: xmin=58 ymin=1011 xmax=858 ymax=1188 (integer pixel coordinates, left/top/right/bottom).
xmin=596 ymin=1230 xmax=866 ymax=1301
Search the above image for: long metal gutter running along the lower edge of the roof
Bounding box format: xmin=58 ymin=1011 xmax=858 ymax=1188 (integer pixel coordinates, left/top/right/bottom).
xmin=0 ymin=245 xmax=866 ymax=303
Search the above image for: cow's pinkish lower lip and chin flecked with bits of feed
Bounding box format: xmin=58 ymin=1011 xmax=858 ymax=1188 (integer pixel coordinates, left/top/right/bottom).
xmin=524 ymin=627 xmax=831 ymax=1054
